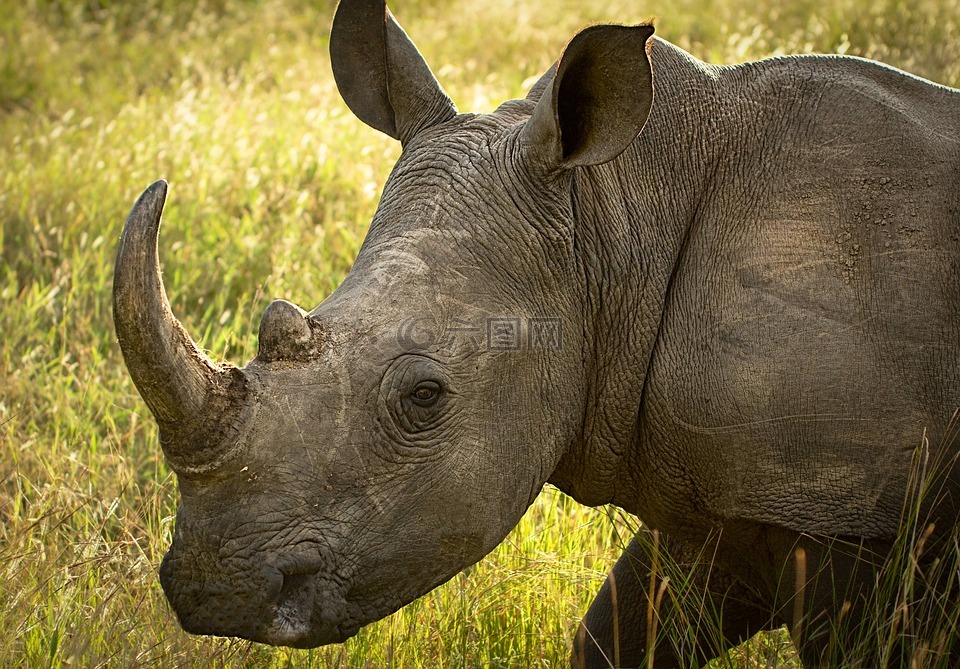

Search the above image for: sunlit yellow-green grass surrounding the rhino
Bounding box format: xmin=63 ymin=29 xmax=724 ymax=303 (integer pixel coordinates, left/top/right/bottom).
xmin=0 ymin=0 xmax=960 ymax=667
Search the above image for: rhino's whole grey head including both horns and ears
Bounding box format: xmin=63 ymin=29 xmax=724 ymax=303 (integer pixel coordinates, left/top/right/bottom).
xmin=114 ymin=0 xmax=653 ymax=647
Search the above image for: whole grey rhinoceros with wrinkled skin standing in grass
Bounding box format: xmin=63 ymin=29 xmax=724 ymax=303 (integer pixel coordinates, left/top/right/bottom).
xmin=114 ymin=0 xmax=960 ymax=667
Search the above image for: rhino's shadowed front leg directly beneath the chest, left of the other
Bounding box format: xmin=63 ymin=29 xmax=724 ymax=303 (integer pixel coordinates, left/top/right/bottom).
xmin=571 ymin=531 xmax=772 ymax=669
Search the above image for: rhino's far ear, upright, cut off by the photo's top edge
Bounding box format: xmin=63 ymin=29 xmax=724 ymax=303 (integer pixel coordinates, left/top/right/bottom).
xmin=330 ymin=0 xmax=457 ymax=143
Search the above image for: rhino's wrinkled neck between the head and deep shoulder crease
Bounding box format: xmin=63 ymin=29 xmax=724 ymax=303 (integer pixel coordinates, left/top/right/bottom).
xmin=550 ymin=40 xmax=719 ymax=512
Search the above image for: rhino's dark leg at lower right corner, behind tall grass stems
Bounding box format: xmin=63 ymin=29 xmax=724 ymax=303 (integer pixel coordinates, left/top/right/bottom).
xmin=774 ymin=533 xmax=960 ymax=668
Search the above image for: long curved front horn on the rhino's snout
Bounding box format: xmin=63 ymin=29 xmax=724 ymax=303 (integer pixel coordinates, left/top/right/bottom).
xmin=113 ymin=181 xmax=245 ymax=464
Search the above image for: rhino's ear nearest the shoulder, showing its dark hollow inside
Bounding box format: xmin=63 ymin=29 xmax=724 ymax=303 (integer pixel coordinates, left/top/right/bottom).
xmin=522 ymin=25 xmax=653 ymax=169
